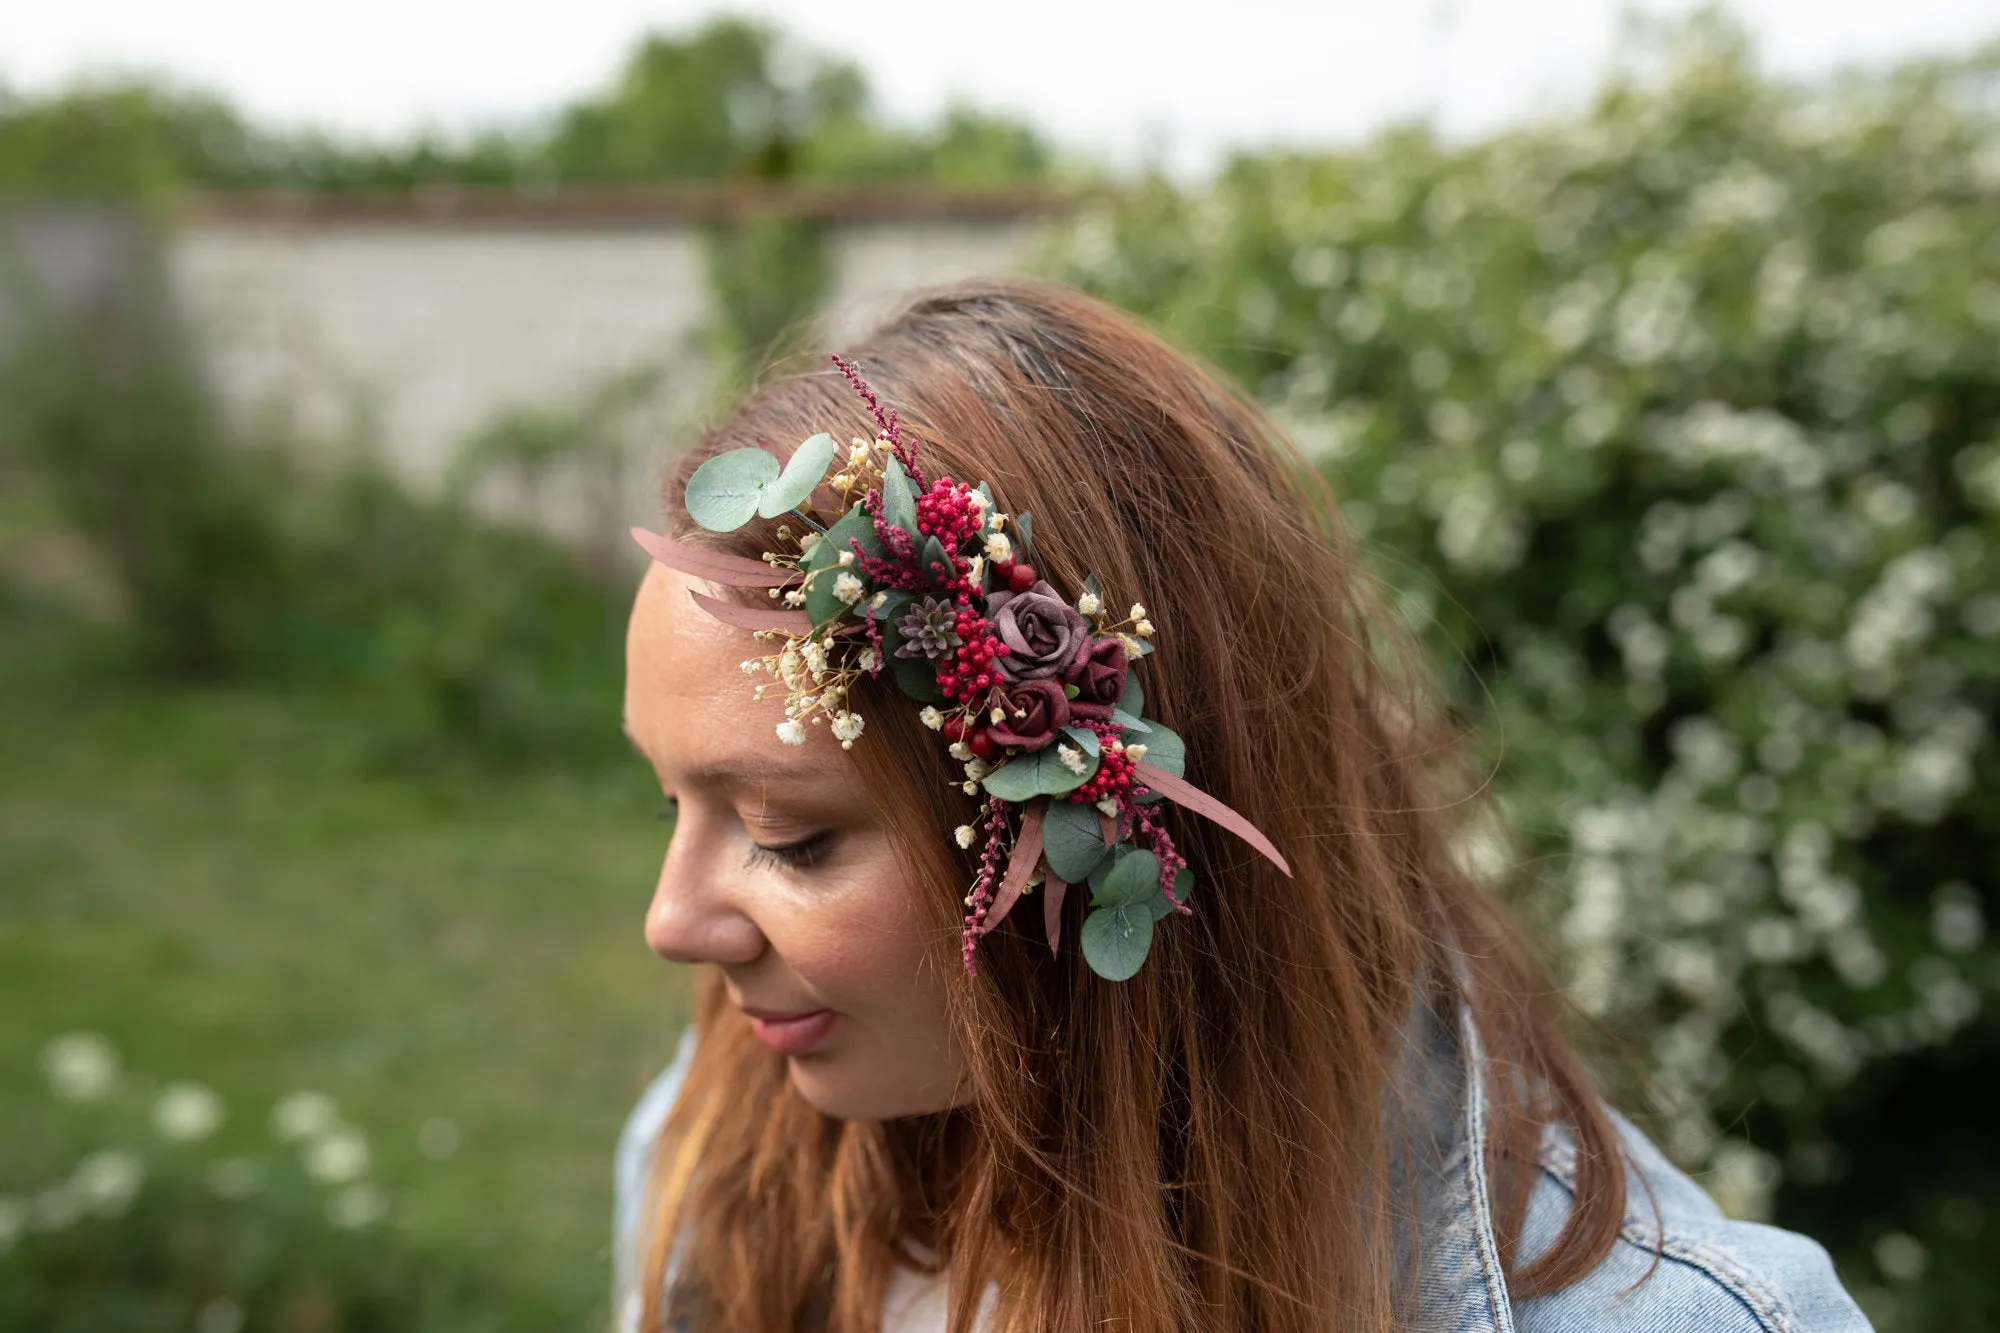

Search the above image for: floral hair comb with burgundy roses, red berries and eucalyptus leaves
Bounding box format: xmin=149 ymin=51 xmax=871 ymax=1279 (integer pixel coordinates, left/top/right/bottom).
xmin=632 ymin=356 xmax=1292 ymax=981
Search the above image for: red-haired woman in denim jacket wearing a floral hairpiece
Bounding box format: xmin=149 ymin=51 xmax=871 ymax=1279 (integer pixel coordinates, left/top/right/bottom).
xmin=618 ymin=284 xmax=1866 ymax=1333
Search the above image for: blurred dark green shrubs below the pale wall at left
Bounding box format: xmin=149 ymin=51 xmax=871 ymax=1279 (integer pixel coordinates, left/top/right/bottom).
xmin=0 ymin=233 xmax=626 ymax=761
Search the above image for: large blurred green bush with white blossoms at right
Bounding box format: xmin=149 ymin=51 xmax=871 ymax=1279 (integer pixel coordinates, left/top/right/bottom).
xmin=1050 ymin=20 xmax=2000 ymax=1331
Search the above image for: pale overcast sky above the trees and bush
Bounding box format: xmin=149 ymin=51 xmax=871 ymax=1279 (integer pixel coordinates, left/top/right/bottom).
xmin=0 ymin=0 xmax=2000 ymax=168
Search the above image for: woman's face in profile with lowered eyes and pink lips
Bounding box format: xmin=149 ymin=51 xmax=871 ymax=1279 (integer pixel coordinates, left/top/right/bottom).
xmin=624 ymin=564 xmax=964 ymax=1121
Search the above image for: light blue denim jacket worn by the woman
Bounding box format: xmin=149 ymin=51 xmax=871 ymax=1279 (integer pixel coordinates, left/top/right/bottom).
xmin=614 ymin=1017 xmax=1868 ymax=1333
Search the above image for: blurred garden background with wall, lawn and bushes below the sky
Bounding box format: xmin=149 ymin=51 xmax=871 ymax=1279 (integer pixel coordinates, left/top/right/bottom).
xmin=0 ymin=12 xmax=2000 ymax=1333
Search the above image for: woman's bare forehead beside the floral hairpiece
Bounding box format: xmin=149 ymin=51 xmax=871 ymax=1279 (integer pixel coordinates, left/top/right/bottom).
xmin=624 ymin=562 xmax=852 ymax=787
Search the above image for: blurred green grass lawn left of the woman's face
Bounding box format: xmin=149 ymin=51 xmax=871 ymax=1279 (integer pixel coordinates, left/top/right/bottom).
xmin=0 ymin=630 xmax=686 ymax=1327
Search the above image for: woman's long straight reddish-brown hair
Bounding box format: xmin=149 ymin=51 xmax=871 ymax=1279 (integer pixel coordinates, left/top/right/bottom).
xmin=642 ymin=282 xmax=1624 ymax=1333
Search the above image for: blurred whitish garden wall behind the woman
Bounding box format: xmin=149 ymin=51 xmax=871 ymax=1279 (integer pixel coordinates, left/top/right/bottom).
xmin=170 ymin=218 xmax=1034 ymax=482
